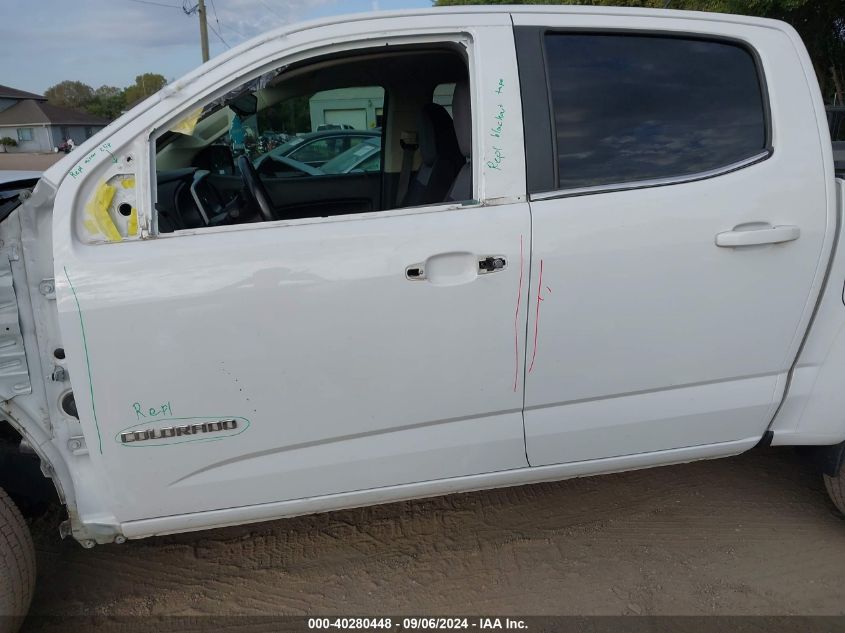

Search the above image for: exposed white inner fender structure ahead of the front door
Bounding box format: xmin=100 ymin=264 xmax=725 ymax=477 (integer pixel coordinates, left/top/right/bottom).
xmin=0 ymin=172 xmax=124 ymax=547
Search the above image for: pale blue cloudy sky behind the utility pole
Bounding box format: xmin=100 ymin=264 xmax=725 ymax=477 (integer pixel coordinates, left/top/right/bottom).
xmin=0 ymin=0 xmax=431 ymax=93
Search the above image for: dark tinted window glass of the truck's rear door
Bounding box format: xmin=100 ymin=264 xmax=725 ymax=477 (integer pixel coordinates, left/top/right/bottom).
xmin=546 ymin=33 xmax=766 ymax=189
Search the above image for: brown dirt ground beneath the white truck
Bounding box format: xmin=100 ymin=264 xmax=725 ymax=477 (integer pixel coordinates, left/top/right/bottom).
xmin=14 ymin=449 xmax=845 ymax=631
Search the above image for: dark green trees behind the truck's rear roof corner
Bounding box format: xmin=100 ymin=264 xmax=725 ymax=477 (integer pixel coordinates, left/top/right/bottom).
xmin=434 ymin=0 xmax=845 ymax=103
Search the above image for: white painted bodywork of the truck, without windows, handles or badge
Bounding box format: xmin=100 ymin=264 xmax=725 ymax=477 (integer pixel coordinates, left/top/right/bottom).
xmin=0 ymin=7 xmax=843 ymax=540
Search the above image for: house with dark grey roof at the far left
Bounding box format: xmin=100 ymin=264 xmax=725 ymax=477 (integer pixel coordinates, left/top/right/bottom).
xmin=0 ymin=85 xmax=109 ymax=152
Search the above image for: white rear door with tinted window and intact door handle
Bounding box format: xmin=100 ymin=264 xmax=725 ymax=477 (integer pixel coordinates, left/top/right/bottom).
xmin=515 ymin=14 xmax=835 ymax=466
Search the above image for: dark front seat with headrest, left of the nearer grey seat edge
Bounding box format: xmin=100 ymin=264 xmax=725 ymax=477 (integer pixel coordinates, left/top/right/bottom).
xmin=402 ymin=103 xmax=466 ymax=207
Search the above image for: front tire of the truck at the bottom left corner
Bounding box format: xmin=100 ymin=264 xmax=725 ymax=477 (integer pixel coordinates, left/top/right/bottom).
xmin=0 ymin=488 xmax=35 ymax=633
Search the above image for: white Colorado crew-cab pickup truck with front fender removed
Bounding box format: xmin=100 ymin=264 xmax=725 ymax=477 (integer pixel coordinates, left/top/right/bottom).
xmin=0 ymin=7 xmax=845 ymax=614
